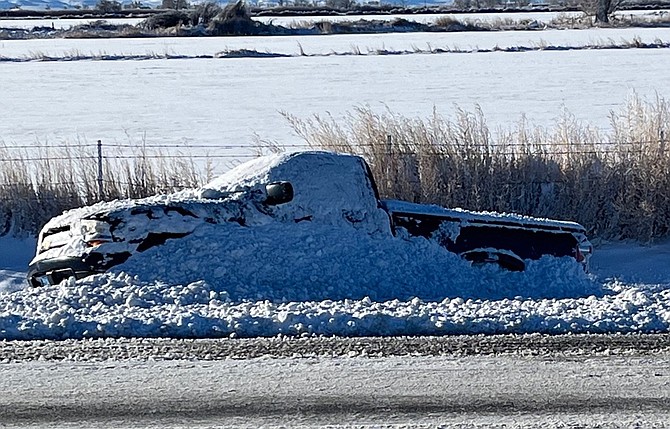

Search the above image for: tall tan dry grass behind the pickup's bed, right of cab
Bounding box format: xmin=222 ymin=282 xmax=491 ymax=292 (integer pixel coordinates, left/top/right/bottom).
xmin=285 ymin=96 xmax=670 ymax=242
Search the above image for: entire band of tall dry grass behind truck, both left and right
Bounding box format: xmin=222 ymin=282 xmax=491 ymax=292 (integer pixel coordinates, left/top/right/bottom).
xmin=5 ymin=96 xmax=670 ymax=242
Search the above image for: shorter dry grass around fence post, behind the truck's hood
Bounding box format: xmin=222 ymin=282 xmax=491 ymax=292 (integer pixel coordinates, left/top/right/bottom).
xmin=0 ymin=142 xmax=211 ymax=236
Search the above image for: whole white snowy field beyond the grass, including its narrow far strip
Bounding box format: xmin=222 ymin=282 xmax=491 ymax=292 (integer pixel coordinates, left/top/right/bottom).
xmin=0 ymin=28 xmax=670 ymax=173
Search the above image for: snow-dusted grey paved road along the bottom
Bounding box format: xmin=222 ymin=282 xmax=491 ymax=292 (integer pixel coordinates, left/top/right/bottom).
xmin=0 ymin=336 xmax=670 ymax=428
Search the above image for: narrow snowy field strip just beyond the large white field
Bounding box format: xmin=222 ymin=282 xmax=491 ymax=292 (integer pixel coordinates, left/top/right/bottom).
xmin=0 ymin=28 xmax=670 ymax=59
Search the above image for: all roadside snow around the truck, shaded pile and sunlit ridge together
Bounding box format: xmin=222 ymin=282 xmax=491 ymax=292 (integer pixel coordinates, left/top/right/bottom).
xmin=0 ymin=214 xmax=670 ymax=339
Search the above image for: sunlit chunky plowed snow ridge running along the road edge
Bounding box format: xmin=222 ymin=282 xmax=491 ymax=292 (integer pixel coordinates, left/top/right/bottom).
xmin=0 ymin=273 xmax=670 ymax=339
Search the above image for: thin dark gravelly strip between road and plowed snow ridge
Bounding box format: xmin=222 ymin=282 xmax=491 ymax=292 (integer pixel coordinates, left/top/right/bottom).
xmin=0 ymin=333 xmax=670 ymax=363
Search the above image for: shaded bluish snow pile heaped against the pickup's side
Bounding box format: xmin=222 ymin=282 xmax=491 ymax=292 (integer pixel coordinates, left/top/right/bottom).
xmin=112 ymin=222 xmax=602 ymax=302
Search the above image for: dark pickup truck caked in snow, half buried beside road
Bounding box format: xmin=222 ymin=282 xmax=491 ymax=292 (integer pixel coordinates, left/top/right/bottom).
xmin=28 ymin=151 xmax=591 ymax=286
